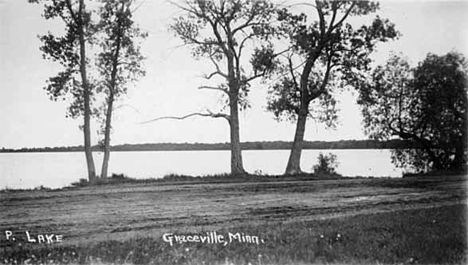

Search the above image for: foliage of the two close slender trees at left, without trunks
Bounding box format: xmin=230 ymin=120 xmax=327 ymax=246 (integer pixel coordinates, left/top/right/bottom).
xmin=34 ymin=0 xmax=147 ymax=121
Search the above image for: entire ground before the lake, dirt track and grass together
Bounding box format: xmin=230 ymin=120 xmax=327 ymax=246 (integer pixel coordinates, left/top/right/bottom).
xmin=0 ymin=174 xmax=467 ymax=264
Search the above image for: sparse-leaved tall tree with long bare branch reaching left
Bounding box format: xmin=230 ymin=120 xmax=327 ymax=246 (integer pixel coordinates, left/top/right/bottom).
xmin=167 ymin=0 xmax=275 ymax=174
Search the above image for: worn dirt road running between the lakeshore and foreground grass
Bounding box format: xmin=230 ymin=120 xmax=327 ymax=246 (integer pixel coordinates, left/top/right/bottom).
xmin=0 ymin=177 xmax=467 ymax=244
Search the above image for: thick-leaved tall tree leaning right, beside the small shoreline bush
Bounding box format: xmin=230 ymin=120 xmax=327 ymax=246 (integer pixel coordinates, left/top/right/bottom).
xmin=268 ymin=0 xmax=398 ymax=174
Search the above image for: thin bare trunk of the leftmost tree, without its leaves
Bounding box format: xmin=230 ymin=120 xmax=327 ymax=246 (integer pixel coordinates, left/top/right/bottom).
xmin=79 ymin=0 xmax=96 ymax=182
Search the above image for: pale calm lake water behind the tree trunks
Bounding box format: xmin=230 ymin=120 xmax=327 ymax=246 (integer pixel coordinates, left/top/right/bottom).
xmin=0 ymin=149 xmax=402 ymax=188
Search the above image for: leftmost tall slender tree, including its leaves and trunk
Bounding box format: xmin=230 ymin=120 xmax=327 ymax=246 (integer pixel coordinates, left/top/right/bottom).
xmin=30 ymin=0 xmax=96 ymax=182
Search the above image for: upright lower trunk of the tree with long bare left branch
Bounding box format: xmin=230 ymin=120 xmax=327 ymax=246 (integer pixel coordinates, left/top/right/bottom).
xmin=229 ymin=95 xmax=245 ymax=175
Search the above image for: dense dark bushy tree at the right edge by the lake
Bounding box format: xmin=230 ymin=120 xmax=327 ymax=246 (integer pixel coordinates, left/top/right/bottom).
xmin=358 ymin=52 xmax=468 ymax=171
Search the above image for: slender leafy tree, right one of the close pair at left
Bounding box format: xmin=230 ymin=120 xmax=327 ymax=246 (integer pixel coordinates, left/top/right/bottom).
xmin=97 ymin=0 xmax=146 ymax=178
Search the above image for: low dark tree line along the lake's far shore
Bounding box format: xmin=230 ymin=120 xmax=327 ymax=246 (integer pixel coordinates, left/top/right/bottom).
xmin=0 ymin=139 xmax=420 ymax=153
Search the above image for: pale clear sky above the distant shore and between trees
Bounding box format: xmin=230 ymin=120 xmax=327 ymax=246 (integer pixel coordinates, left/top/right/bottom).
xmin=0 ymin=0 xmax=468 ymax=148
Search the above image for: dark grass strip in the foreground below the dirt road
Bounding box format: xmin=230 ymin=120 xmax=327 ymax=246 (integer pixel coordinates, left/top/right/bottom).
xmin=0 ymin=204 xmax=467 ymax=264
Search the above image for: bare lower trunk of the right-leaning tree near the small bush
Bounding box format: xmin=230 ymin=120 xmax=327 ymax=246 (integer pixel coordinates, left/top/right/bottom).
xmin=285 ymin=104 xmax=309 ymax=175
